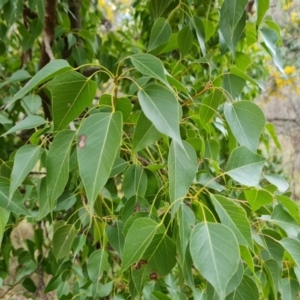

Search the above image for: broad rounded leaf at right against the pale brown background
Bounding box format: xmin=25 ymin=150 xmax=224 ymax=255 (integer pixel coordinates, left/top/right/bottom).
xmin=224 ymin=101 xmax=266 ymax=152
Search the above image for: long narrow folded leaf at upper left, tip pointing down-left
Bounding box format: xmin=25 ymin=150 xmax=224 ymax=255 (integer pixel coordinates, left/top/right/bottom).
xmin=6 ymin=59 xmax=72 ymax=107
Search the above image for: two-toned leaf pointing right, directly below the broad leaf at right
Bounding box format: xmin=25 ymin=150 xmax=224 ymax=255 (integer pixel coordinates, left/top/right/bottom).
xmin=226 ymin=146 xmax=265 ymax=186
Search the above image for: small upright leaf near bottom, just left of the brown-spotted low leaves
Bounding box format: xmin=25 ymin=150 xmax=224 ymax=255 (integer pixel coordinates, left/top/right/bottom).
xmin=87 ymin=249 xmax=110 ymax=281
